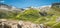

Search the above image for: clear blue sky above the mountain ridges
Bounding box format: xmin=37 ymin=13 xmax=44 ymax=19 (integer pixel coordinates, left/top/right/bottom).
xmin=2 ymin=0 xmax=60 ymax=8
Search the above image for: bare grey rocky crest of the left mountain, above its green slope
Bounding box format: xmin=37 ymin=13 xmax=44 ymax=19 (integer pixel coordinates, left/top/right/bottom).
xmin=0 ymin=3 xmax=22 ymax=12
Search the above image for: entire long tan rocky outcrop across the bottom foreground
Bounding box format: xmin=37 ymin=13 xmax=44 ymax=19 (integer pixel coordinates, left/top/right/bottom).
xmin=0 ymin=19 xmax=47 ymax=28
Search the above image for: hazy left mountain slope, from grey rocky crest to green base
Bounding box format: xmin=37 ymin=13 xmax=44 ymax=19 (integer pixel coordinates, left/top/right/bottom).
xmin=0 ymin=3 xmax=23 ymax=18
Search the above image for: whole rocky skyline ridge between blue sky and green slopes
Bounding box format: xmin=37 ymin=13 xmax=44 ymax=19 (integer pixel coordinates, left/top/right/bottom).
xmin=0 ymin=3 xmax=60 ymax=12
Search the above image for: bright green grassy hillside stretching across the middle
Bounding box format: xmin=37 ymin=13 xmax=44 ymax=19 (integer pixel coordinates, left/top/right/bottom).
xmin=0 ymin=2 xmax=60 ymax=28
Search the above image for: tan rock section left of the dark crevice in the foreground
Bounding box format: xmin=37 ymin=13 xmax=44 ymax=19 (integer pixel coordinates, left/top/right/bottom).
xmin=1 ymin=19 xmax=18 ymax=28
